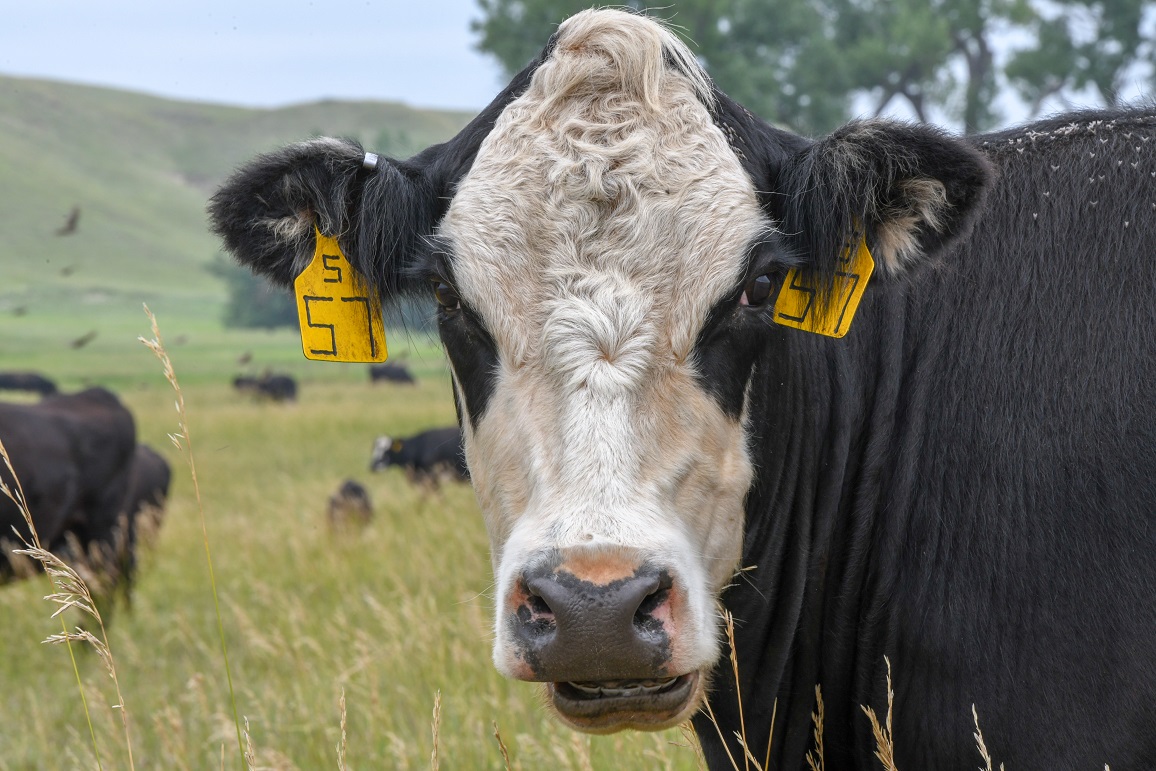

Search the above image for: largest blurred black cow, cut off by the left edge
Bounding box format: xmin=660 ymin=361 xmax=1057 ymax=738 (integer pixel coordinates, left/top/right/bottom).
xmin=0 ymin=387 xmax=136 ymax=593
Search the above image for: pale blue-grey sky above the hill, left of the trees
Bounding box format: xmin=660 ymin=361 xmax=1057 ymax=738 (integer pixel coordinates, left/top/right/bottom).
xmin=0 ymin=0 xmax=505 ymax=111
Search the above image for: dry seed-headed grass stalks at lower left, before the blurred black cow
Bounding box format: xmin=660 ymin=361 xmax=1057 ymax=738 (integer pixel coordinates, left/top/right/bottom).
xmin=0 ymin=442 xmax=135 ymax=771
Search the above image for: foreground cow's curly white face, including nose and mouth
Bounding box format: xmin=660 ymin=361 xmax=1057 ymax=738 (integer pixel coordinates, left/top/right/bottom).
xmin=439 ymin=15 xmax=769 ymax=731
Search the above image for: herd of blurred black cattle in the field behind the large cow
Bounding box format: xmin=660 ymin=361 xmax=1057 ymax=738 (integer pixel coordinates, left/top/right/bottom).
xmin=0 ymin=363 xmax=469 ymax=600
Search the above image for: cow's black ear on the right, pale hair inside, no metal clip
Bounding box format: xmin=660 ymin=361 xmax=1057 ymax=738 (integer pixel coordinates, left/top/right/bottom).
xmin=772 ymin=120 xmax=993 ymax=283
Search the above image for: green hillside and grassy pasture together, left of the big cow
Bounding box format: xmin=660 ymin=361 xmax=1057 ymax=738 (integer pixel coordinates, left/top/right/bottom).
xmin=0 ymin=77 xmax=697 ymax=771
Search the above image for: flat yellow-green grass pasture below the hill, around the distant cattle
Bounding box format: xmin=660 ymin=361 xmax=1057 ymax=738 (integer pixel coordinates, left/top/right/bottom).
xmin=0 ymin=309 xmax=698 ymax=770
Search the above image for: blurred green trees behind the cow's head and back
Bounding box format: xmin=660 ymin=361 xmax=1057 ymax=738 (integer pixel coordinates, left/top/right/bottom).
xmin=473 ymin=0 xmax=1156 ymax=133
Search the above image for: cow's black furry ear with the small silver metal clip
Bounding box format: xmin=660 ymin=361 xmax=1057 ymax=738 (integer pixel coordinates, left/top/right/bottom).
xmin=208 ymin=138 xmax=436 ymax=295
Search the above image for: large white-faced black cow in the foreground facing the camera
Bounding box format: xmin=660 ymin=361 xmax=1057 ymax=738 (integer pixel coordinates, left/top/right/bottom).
xmin=209 ymin=10 xmax=1156 ymax=771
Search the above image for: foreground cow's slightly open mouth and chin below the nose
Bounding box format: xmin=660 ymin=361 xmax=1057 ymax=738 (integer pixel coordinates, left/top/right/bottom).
xmin=547 ymin=672 xmax=699 ymax=733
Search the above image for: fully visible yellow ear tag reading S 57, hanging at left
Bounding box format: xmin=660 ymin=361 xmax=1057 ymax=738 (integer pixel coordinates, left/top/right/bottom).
xmin=292 ymin=228 xmax=390 ymax=362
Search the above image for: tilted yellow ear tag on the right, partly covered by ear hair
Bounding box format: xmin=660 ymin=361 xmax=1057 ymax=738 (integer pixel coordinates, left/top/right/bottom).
xmin=775 ymin=236 xmax=875 ymax=338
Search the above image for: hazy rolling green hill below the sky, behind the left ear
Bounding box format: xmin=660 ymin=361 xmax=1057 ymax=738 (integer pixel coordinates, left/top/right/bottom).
xmin=0 ymin=77 xmax=470 ymax=319
